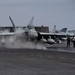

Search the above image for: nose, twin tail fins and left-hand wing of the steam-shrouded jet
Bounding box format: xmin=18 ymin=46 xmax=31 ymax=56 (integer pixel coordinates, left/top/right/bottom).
xmin=0 ymin=16 xmax=38 ymax=43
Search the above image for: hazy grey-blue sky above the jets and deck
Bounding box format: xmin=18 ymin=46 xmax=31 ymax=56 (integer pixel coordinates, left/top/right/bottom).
xmin=0 ymin=0 xmax=75 ymax=30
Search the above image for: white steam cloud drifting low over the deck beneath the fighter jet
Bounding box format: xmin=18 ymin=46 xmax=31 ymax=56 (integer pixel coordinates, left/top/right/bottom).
xmin=0 ymin=33 xmax=46 ymax=49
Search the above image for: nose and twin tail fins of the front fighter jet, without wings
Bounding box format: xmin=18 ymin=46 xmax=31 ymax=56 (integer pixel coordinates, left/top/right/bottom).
xmin=9 ymin=16 xmax=38 ymax=40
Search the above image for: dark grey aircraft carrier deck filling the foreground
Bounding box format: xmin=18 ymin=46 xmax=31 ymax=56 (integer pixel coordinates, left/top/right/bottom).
xmin=0 ymin=47 xmax=75 ymax=75
